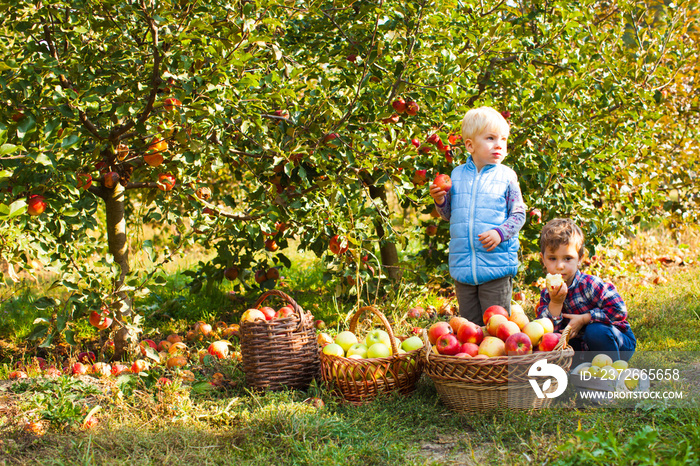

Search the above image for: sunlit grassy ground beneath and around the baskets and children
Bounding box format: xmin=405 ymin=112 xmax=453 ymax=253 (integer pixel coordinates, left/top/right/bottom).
xmin=0 ymin=228 xmax=700 ymax=465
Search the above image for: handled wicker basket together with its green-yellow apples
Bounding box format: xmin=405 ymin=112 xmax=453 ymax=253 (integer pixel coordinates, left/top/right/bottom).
xmin=320 ymin=306 xmax=423 ymax=405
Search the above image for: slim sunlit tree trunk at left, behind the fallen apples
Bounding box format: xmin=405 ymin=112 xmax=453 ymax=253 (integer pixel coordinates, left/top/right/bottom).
xmin=104 ymin=184 xmax=138 ymax=360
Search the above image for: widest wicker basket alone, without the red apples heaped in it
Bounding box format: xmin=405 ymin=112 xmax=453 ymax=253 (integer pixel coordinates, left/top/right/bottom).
xmin=423 ymin=329 xmax=574 ymax=413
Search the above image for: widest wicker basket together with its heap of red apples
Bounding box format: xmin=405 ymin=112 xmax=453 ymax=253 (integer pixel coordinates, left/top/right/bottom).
xmin=423 ymin=304 xmax=574 ymax=413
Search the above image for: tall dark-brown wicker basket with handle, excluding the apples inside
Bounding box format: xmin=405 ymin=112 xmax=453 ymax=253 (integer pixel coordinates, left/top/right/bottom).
xmin=240 ymin=290 xmax=319 ymax=390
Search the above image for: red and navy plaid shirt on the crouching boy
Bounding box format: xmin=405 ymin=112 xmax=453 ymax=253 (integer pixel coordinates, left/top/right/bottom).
xmin=537 ymin=271 xmax=630 ymax=332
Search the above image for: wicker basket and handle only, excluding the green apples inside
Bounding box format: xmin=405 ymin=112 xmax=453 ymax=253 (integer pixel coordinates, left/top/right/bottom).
xmin=321 ymin=306 xmax=423 ymax=405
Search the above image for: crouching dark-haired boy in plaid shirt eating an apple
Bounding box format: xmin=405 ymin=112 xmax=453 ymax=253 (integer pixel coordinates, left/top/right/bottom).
xmin=537 ymin=218 xmax=637 ymax=361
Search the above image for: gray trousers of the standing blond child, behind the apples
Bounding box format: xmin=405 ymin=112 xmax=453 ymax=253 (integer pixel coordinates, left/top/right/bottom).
xmin=455 ymin=275 xmax=513 ymax=325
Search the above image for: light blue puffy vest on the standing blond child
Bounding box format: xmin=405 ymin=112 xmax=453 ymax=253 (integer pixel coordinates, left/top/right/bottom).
xmin=449 ymin=157 xmax=520 ymax=285
